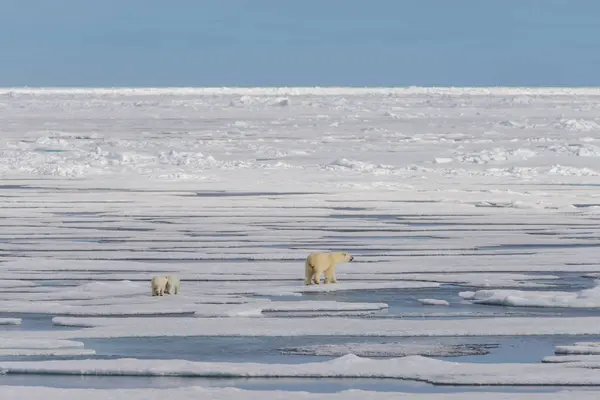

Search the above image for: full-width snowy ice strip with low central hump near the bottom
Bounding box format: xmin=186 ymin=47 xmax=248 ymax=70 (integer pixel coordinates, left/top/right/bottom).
xmin=0 ymin=354 xmax=600 ymax=386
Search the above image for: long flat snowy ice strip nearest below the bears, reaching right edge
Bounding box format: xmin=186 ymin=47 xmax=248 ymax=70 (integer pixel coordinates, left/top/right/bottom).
xmin=34 ymin=317 xmax=600 ymax=340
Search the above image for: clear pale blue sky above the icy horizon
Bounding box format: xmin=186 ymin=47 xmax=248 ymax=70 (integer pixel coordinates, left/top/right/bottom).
xmin=0 ymin=0 xmax=600 ymax=86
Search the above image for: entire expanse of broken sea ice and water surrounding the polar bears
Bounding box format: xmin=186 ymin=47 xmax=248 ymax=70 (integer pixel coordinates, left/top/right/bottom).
xmin=0 ymin=89 xmax=600 ymax=394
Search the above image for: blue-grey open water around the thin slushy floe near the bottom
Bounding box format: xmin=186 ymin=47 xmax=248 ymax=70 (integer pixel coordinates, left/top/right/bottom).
xmin=70 ymin=335 xmax=600 ymax=364
